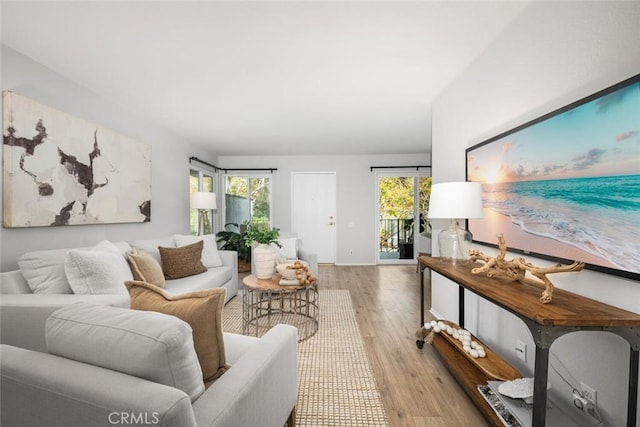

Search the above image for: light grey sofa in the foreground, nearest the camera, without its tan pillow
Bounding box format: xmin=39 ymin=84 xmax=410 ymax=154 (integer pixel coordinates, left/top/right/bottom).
xmin=0 ymin=303 xmax=297 ymax=427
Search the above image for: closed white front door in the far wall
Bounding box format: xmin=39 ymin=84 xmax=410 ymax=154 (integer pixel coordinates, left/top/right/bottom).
xmin=291 ymin=172 xmax=336 ymax=264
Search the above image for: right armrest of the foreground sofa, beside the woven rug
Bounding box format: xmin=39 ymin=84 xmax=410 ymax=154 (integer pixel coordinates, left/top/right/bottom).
xmin=193 ymin=324 xmax=298 ymax=427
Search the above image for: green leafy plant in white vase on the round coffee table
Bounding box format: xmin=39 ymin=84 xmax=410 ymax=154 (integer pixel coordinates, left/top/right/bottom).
xmin=244 ymin=224 xmax=282 ymax=279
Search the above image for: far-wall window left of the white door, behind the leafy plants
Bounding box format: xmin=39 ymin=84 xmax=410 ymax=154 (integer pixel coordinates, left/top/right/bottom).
xmin=224 ymin=175 xmax=271 ymax=232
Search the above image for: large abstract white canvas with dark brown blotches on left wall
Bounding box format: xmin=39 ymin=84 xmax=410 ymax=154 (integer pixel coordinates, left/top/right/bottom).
xmin=2 ymin=91 xmax=151 ymax=228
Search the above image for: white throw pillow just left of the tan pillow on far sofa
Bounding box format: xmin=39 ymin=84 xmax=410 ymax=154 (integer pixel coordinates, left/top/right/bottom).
xmin=64 ymin=240 xmax=133 ymax=295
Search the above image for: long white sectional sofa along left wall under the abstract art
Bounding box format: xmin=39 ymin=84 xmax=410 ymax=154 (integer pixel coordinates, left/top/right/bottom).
xmin=0 ymin=235 xmax=238 ymax=351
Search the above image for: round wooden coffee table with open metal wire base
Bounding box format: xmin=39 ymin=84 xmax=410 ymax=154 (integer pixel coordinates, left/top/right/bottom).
xmin=242 ymin=274 xmax=318 ymax=341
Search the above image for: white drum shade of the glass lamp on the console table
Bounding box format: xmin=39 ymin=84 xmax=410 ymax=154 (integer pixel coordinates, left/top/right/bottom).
xmin=427 ymin=182 xmax=483 ymax=219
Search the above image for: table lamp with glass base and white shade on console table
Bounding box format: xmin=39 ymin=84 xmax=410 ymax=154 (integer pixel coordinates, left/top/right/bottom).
xmin=427 ymin=182 xmax=483 ymax=263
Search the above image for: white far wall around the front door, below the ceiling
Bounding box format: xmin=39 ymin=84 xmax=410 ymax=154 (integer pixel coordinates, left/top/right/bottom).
xmin=217 ymin=154 xmax=430 ymax=265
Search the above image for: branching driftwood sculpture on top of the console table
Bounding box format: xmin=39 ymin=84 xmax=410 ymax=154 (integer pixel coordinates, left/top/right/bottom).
xmin=469 ymin=234 xmax=584 ymax=304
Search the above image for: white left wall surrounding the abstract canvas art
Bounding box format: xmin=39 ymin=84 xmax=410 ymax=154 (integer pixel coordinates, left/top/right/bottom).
xmin=0 ymin=45 xmax=216 ymax=271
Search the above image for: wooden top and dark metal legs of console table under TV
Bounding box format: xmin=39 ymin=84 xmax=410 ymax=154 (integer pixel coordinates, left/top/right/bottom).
xmin=418 ymin=256 xmax=640 ymax=427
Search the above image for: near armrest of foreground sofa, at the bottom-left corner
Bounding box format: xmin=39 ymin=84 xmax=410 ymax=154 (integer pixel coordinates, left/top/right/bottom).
xmin=0 ymin=345 xmax=196 ymax=427
